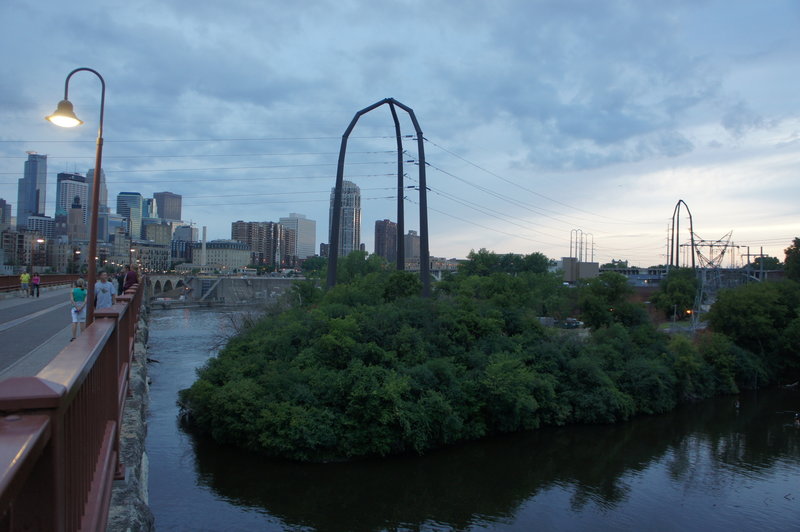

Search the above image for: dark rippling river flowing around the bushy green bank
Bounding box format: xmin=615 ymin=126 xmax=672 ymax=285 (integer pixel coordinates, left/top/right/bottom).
xmin=146 ymin=309 xmax=800 ymax=531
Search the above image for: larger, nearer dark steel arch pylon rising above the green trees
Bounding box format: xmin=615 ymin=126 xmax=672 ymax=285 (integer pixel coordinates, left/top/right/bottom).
xmin=328 ymin=98 xmax=431 ymax=297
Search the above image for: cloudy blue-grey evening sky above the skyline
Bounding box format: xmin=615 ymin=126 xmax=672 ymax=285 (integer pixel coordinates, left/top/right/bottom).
xmin=0 ymin=0 xmax=800 ymax=266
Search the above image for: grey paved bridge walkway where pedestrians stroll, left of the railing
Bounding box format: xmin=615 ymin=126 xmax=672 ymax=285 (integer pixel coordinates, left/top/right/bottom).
xmin=0 ymin=287 xmax=72 ymax=380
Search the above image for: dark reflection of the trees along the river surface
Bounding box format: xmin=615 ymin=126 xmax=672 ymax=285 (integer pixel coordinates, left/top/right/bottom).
xmin=183 ymin=388 xmax=800 ymax=530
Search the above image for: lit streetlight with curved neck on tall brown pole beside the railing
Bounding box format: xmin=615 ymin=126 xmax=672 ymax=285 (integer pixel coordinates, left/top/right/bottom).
xmin=45 ymin=67 xmax=106 ymax=325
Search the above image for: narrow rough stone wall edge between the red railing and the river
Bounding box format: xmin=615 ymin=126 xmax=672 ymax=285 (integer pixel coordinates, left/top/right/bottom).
xmin=106 ymin=305 xmax=155 ymax=532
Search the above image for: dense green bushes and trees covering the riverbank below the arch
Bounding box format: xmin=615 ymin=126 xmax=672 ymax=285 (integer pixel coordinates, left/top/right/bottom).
xmin=179 ymin=250 xmax=800 ymax=461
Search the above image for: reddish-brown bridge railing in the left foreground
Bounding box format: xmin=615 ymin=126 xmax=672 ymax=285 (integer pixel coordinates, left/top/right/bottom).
xmin=0 ymin=284 xmax=144 ymax=531
